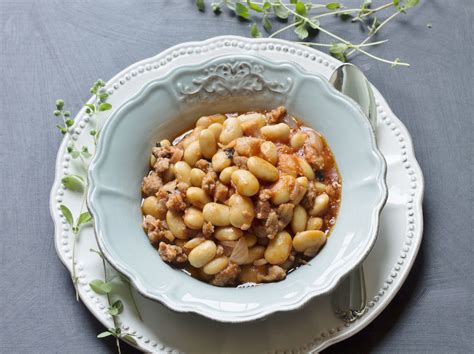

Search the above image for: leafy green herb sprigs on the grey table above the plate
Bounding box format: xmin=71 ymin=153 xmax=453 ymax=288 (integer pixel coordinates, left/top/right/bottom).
xmin=196 ymin=0 xmax=419 ymax=67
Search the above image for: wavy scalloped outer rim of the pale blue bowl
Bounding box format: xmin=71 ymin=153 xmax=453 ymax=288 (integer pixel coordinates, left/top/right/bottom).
xmin=87 ymin=54 xmax=388 ymax=323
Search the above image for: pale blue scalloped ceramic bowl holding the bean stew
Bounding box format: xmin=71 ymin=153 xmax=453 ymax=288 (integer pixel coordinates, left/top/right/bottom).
xmin=88 ymin=55 xmax=387 ymax=322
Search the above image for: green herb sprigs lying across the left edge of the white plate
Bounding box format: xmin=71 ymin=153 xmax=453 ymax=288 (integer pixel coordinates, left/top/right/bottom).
xmin=53 ymin=80 xmax=142 ymax=353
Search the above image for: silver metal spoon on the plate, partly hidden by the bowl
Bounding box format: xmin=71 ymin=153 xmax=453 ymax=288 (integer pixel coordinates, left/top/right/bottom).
xmin=329 ymin=63 xmax=377 ymax=322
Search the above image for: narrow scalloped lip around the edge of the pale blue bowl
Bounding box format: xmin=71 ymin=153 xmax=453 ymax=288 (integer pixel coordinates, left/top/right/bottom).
xmin=86 ymin=54 xmax=388 ymax=323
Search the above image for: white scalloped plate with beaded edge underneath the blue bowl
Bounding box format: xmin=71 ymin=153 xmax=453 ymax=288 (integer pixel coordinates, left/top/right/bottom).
xmin=50 ymin=36 xmax=423 ymax=353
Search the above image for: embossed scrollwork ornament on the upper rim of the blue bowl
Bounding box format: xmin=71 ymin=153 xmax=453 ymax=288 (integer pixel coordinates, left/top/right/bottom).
xmin=178 ymin=61 xmax=293 ymax=98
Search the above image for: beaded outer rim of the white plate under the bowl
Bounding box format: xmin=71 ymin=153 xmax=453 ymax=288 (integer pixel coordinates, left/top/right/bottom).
xmin=50 ymin=35 xmax=424 ymax=352
